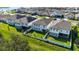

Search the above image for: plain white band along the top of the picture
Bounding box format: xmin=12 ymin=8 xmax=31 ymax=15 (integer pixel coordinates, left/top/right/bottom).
xmin=0 ymin=0 xmax=79 ymax=7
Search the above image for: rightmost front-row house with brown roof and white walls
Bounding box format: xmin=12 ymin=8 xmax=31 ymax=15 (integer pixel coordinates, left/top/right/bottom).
xmin=49 ymin=20 xmax=71 ymax=38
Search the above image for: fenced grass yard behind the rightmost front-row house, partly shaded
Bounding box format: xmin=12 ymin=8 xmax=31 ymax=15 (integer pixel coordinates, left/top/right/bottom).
xmin=47 ymin=36 xmax=70 ymax=46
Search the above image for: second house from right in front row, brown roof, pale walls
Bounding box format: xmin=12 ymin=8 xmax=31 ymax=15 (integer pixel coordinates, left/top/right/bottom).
xmin=32 ymin=18 xmax=52 ymax=32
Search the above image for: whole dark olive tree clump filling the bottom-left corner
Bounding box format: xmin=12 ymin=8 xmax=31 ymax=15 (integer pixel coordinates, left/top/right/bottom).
xmin=0 ymin=34 xmax=30 ymax=51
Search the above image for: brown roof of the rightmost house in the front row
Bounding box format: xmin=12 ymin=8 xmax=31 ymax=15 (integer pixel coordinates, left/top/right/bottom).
xmin=51 ymin=20 xmax=71 ymax=30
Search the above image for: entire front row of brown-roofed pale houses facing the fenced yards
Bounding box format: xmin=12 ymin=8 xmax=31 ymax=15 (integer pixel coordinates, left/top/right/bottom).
xmin=0 ymin=14 xmax=71 ymax=38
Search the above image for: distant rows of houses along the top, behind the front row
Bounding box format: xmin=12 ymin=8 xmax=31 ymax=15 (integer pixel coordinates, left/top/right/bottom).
xmin=16 ymin=7 xmax=79 ymax=19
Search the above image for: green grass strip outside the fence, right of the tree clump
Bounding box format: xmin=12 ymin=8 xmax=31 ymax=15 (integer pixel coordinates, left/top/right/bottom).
xmin=28 ymin=38 xmax=68 ymax=51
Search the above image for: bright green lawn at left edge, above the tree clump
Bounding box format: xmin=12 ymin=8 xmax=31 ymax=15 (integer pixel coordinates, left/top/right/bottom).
xmin=0 ymin=23 xmax=17 ymax=40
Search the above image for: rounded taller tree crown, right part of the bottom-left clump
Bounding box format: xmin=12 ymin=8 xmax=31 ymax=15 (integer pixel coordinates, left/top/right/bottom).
xmin=9 ymin=35 xmax=29 ymax=51
